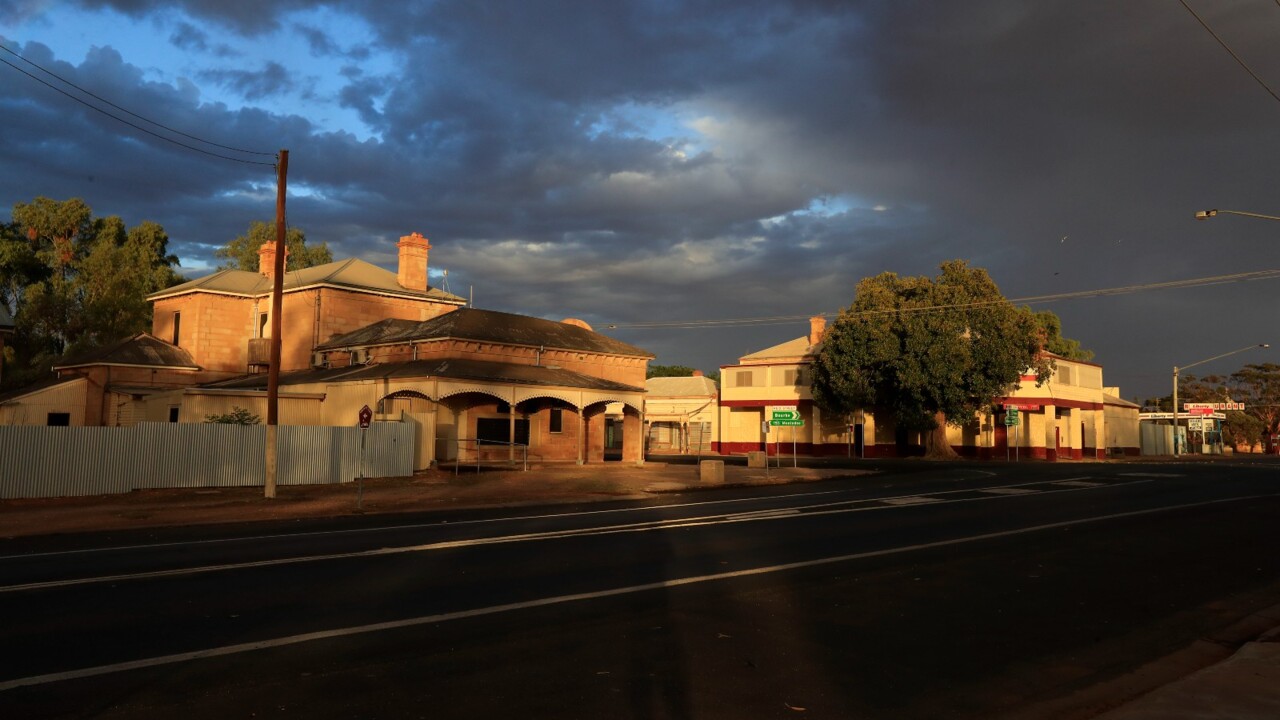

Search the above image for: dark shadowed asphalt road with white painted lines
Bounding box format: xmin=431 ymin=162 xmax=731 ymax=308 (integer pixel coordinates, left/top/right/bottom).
xmin=0 ymin=456 xmax=1280 ymax=719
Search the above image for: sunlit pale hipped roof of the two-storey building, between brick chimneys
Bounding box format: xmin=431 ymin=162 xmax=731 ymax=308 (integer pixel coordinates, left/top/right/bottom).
xmin=147 ymin=258 xmax=466 ymax=304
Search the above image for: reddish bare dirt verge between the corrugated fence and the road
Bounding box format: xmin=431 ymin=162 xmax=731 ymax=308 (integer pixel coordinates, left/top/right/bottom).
xmin=0 ymin=462 xmax=861 ymax=537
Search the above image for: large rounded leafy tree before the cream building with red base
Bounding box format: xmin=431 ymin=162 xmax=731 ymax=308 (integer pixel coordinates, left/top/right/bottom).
xmin=813 ymin=260 xmax=1053 ymax=457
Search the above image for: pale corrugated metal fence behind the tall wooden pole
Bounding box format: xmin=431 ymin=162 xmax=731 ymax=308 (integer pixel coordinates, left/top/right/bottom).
xmin=0 ymin=423 xmax=413 ymax=498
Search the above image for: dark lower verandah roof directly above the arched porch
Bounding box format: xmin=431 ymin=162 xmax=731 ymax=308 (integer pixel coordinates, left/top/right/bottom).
xmin=200 ymin=359 xmax=644 ymax=392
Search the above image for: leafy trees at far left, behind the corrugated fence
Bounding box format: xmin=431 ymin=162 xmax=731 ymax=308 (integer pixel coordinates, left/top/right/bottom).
xmin=0 ymin=197 xmax=180 ymax=387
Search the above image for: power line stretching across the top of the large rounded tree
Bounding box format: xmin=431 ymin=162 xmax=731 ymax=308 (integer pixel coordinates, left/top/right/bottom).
xmin=605 ymin=269 xmax=1280 ymax=329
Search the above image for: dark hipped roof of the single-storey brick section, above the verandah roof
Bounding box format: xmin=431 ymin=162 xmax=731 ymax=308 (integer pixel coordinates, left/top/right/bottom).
xmin=316 ymin=307 xmax=655 ymax=357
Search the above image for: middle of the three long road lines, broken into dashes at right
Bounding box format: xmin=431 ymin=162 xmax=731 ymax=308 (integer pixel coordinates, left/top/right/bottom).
xmin=0 ymin=480 xmax=1151 ymax=593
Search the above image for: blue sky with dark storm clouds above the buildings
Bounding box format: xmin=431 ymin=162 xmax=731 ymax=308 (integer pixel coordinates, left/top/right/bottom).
xmin=0 ymin=0 xmax=1280 ymax=400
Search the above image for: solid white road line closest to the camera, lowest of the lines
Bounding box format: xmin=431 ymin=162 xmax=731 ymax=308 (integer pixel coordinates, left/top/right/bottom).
xmin=0 ymin=493 xmax=1280 ymax=692
